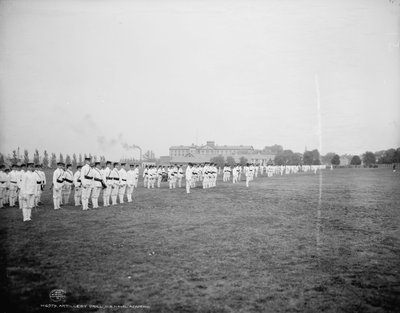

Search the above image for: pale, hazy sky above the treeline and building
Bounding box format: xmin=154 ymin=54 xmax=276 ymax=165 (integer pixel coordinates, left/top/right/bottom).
xmin=0 ymin=0 xmax=400 ymax=159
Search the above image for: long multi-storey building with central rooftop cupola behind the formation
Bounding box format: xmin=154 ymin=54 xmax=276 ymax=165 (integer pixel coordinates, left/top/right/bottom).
xmin=169 ymin=141 xmax=275 ymax=164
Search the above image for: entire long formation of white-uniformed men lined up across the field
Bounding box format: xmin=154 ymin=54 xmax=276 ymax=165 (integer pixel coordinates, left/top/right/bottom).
xmin=0 ymin=158 xmax=326 ymax=221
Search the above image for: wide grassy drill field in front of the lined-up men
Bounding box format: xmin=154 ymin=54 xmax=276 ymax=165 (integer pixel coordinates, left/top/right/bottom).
xmin=0 ymin=168 xmax=400 ymax=312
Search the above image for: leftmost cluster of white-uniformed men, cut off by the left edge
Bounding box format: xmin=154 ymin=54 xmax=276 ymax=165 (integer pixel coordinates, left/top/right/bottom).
xmin=0 ymin=163 xmax=46 ymax=222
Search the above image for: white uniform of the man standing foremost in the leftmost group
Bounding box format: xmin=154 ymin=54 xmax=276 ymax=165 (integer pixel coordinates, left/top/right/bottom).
xmin=20 ymin=171 xmax=37 ymax=222
